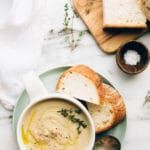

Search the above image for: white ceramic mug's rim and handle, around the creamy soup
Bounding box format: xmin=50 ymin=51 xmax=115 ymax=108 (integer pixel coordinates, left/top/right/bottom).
xmin=17 ymin=73 xmax=95 ymax=150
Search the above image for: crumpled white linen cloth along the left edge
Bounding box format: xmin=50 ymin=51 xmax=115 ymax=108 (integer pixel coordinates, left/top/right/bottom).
xmin=0 ymin=0 xmax=50 ymax=107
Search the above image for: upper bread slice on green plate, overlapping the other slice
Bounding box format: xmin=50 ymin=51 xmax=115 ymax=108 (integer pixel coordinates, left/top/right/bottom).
xmin=56 ymin=65 xmax=102 ymax=104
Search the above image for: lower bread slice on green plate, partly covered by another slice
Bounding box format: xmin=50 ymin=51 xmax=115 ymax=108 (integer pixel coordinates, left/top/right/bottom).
xmin=87 ymin=83 xmax=126 ymax=133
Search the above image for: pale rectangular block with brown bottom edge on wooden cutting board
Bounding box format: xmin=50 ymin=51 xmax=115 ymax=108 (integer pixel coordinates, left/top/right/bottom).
xmin=103 ymin=0 xmax=147 ymax=28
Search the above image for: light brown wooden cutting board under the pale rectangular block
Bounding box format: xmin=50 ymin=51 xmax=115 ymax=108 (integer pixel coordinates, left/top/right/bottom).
xmin=73 ymin=0 xmax=148 ymax=53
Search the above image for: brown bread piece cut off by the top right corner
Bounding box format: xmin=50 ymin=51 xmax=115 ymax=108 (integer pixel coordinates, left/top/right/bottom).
xmin=140 ymin=0 xmax=150 ymax=21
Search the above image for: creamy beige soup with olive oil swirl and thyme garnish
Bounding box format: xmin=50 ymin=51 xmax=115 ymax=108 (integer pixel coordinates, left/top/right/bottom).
xmin=22 ymin=99 xmax=91 ymax=150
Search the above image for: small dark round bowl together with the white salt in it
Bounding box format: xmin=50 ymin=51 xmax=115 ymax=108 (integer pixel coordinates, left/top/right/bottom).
xmin=116 ymin=41 xmax=150 ymax=74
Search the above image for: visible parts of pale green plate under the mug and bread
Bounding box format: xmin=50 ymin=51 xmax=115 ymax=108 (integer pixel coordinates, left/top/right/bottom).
xmin=13 ymin=66 xmax=127 ymax=142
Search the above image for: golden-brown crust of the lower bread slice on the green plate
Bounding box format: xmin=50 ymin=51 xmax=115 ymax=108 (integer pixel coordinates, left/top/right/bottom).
xmin=96 ymin=83 xmax=126 ymax=133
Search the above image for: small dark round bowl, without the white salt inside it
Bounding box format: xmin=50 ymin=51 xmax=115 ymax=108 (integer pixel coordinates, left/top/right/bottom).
xmin=116 ymin=41 xmax=150 ymax=75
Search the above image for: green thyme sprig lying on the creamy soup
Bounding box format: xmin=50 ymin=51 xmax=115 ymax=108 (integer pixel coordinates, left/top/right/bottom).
xmin=57 ymin=109 xmax=87 ymax=134
